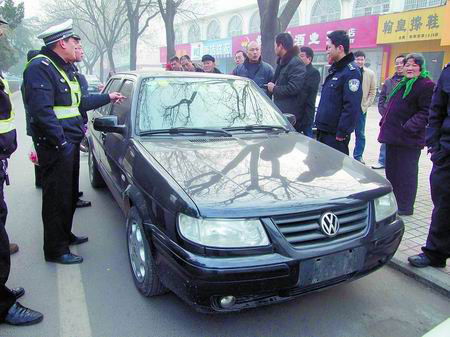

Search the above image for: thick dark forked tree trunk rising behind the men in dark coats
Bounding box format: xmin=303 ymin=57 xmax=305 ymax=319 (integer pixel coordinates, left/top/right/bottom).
xmin=258 ymin=0 xmax=302 ymax=65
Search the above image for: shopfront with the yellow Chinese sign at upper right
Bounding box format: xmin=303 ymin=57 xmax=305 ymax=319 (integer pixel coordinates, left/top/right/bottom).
xmin=377 ymin=5 xmax=450 ymax=81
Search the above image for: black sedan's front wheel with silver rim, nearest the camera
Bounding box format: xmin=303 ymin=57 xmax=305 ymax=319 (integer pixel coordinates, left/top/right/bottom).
xmin=127 ymin=207 xmax=167 ymax=297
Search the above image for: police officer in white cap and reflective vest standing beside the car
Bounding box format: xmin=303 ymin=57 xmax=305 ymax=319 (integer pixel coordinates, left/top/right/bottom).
xmin=23 ymin=20 xmax=123 ymax=264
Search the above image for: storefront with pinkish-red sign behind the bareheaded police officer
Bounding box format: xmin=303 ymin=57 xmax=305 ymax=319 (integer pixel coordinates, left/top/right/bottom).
xmin=233 ymin=15 xmax=384 ymax=86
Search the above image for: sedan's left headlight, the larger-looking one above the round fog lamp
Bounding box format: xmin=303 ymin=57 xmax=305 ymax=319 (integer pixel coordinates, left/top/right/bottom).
xmin=178 ymin=214 xmax=270 ymax=248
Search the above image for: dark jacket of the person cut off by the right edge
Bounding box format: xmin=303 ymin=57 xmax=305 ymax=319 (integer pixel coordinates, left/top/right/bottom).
xmin=426 ymin=63 xmax=450 ymax=160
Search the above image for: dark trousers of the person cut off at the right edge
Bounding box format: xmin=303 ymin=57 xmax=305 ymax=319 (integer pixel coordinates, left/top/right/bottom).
xmin=422 ymin=156 xmax=450 ymax=263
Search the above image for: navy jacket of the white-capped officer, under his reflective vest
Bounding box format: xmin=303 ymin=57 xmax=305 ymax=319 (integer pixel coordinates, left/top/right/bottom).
xmin=23 ymin=47 xmax=84 ymax=148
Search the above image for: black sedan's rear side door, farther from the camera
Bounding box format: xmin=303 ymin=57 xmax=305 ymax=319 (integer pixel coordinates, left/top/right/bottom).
xmin=89 ymin=78 xmax=122 ymax=176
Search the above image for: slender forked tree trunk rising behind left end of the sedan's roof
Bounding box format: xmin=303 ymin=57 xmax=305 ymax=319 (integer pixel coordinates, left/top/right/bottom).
xmin=125 ymin=0 xmax=159 ymax=70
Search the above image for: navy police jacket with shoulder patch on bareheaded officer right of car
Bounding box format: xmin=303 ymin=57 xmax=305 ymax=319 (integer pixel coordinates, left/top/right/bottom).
xmin=315 ymin=53 xmax=362 ymax=137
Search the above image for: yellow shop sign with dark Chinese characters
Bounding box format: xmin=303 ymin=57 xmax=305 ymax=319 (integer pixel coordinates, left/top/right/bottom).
xmin=377 ymin=7 xmax=444 ymax=44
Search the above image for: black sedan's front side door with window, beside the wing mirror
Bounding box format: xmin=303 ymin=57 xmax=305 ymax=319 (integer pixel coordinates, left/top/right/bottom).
xmin=104 ymin=79 xmax=135 ymax=195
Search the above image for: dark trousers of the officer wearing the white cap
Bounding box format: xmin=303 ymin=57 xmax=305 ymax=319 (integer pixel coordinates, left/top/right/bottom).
xmin=35 ymin=143 xmax=79 ymax=258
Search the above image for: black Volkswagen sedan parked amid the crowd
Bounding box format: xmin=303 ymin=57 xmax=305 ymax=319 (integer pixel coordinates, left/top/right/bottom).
xmin=89 ymin=71 xmax=404 ymax=312
